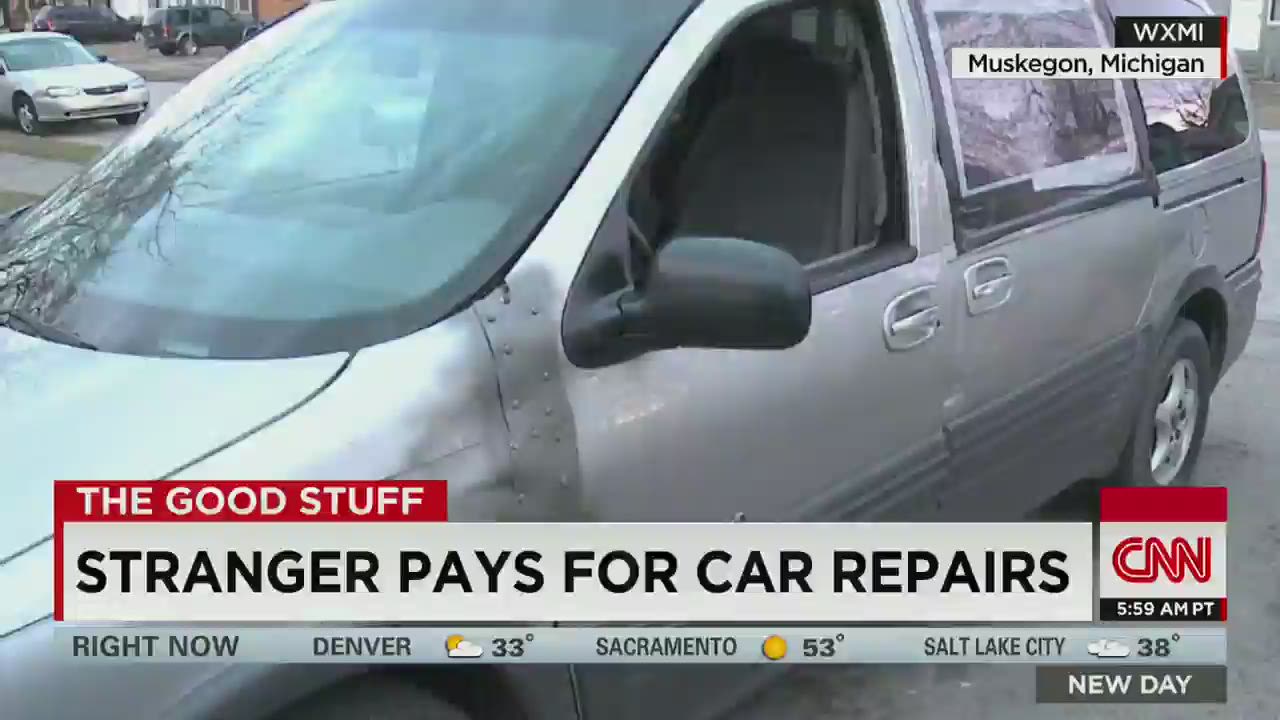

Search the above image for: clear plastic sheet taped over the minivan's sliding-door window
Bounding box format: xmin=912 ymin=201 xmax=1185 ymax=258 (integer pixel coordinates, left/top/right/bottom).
xmin=924 ymin=0 xmax=1137 ymax=195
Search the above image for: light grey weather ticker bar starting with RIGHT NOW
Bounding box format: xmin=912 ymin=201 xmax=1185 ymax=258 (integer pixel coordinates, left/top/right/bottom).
xmin=55 ymin=625 xmax=1226 ymax=667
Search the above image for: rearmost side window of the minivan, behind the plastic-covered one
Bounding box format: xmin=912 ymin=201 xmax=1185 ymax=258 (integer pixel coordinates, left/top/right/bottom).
xmin=1110 ymin=0 xmax=1249 ymax=173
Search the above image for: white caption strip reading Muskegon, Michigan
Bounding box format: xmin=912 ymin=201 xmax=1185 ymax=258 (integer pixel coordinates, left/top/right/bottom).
xmin=951 ymin=47 xmax=1222 ymax=79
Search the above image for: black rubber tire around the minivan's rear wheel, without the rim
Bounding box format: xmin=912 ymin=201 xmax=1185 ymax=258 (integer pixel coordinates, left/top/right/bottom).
xmin=1111 ymin=318 xmax=1216 ymax=486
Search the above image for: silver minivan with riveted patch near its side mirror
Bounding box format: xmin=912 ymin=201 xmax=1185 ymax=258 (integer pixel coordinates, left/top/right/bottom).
xmin=0 ymin=0 xmax=1265 ymax=720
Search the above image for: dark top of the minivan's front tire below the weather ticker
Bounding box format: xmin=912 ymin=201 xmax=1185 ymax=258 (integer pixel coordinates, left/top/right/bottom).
xmin=271 ymin=675 xmax=471 ymax=720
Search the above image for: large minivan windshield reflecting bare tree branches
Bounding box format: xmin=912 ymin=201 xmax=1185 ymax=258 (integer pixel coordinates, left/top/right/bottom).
xmin=0 ymin=0 xmax=694 ymax=359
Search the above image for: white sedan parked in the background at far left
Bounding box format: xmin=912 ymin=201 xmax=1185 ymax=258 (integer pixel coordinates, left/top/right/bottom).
xmin=0 ymin=32 xmax=151 ymax=135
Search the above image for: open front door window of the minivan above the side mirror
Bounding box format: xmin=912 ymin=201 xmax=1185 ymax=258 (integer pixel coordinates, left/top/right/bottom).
xmin=630 ymin=0 xmax=906 ymax=278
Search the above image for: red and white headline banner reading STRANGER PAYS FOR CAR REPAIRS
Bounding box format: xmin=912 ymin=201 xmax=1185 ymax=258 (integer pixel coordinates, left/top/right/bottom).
xmin=54 ymin=482 xmax=1094 ymax=624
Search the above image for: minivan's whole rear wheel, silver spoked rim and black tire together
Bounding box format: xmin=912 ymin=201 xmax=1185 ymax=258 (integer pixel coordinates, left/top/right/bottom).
xmin=1116 ymin=318 xmax=1213 ymax=486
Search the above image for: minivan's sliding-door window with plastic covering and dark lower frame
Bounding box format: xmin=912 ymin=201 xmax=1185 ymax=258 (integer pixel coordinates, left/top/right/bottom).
xmin=915 ymin=0 xmax=1140 ymax=250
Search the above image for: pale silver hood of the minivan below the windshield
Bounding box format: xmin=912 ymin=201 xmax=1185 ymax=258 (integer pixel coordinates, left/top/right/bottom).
xmin=0 ymin=328 xmax=347 ymax=560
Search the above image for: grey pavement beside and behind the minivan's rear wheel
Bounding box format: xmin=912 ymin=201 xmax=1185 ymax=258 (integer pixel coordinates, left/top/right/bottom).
xmin=732 ymin=131 xmax=1280 ymax=720
